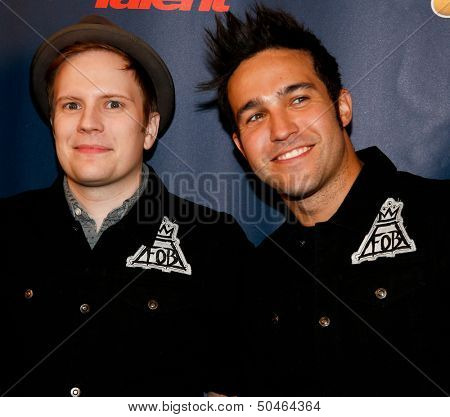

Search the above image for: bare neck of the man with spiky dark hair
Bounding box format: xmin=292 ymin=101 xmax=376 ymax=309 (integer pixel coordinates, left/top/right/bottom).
xmin=282 ymin=133 xmax=362 ymax=227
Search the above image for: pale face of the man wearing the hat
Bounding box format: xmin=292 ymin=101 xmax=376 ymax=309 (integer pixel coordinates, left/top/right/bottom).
xmin=52 ymin=50 xmax=159 ymax=188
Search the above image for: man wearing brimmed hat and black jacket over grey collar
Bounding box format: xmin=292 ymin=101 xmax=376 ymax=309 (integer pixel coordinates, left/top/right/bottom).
xmin=0 ymin=16 xmax=247 ymax=396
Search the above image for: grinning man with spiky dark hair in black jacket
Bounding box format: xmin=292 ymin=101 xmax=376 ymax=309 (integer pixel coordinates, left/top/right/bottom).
xmin=201 ymin=5 xmax=450 ymax=396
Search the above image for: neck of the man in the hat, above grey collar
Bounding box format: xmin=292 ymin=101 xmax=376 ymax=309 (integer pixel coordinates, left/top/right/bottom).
xmin=67 ymin=169 xmax=141 ymax=231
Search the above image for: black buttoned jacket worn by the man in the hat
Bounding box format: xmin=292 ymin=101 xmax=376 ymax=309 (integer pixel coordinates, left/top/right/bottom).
xmin=0 ymin=164 xmax=248 ymax=396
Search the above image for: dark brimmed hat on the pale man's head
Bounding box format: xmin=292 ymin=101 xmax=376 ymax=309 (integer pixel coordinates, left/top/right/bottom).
xmin=30 ymin=15 xmax=175 ymax=136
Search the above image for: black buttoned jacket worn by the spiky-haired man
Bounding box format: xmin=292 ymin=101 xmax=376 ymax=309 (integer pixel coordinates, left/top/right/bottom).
xmin=249 ymin=148 xmax=450 ymax=396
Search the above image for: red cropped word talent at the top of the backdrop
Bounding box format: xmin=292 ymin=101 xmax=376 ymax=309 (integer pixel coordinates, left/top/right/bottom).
xmin=95 ymin=0 xmax=230 ymax=12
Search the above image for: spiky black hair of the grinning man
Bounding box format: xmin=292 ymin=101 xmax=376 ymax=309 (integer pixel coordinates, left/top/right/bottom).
xmin=199 ymin=4 xmax=342 ymax=133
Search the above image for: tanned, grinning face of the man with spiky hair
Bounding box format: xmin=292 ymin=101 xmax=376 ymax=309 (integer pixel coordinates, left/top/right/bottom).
xmin=228 ymin=49 xmax=358 ymax=199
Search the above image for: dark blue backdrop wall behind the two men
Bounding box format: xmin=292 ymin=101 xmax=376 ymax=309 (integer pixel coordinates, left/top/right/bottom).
xmin=0 ymin=0 xmax=450 ymax=243
